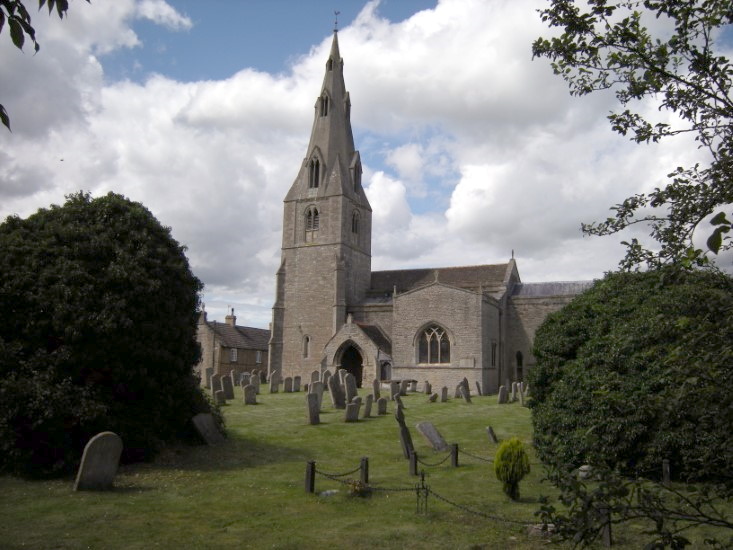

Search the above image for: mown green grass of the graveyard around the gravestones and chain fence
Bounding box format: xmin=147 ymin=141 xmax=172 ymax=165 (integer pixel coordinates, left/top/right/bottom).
xmin=0 ymin=388 xmax=656 ymax=550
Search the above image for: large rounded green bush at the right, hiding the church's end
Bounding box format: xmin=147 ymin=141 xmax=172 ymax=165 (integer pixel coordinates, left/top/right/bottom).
xmin=529 ymin=268 xmax=733 ymax=486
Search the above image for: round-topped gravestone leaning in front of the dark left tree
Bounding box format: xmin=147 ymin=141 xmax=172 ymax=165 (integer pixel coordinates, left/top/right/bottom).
xmin=74 ymin=432 xmax=122 ymax=491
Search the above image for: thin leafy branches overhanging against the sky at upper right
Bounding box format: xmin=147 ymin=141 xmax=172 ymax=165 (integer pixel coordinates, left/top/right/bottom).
xmin=532 ymin=0 xmax=733 ymax=269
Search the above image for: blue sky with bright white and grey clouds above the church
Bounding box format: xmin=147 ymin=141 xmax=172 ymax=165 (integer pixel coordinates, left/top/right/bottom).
xmin=0 ymin=0 xmax=720 ymax=328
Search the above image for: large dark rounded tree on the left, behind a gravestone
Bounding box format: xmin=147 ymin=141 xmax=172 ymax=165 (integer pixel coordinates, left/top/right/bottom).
xmin=0 ymin=193 xmax=216 ymax=475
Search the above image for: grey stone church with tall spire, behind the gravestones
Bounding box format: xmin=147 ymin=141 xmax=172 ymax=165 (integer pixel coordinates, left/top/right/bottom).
xmin=268 ymin=33 xmax=589 ymax=393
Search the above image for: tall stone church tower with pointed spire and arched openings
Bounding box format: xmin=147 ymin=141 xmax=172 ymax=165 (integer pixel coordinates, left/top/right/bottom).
xmin=268 ymin=31 xmax=372 ymax=382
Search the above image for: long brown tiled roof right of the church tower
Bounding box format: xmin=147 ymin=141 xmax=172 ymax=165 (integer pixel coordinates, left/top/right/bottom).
xmin=370 ymin=263 xmax=509 ymax=293
